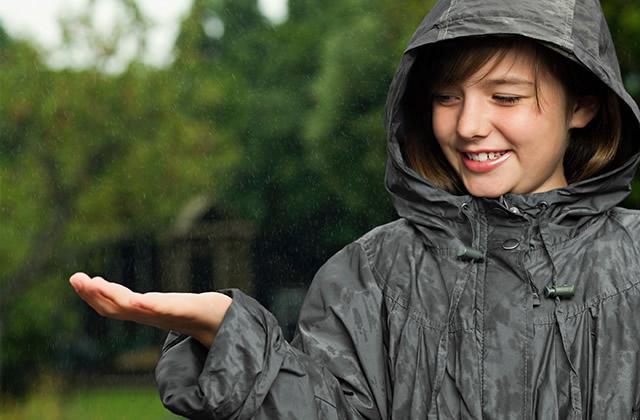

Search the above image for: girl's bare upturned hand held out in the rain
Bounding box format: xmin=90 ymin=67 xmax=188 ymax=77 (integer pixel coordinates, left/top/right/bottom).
xmin=69 ymin=273 xmax=232 ymax=347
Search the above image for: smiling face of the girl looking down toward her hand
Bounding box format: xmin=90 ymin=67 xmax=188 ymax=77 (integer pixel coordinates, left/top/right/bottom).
xmin=432 ymin=46 xmax=588 ymax=197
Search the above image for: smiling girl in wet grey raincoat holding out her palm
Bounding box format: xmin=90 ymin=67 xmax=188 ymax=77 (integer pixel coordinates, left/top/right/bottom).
xmin=71 ymin=0 xmax=640 ymax=419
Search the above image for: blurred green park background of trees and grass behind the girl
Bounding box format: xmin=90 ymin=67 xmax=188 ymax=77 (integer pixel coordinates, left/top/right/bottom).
xmin=0 ymin=0 xmax=640 ymax=419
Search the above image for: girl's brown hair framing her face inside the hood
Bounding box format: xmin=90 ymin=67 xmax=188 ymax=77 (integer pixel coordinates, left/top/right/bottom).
xmin=401 ymin=36 xmax=622 ymax=193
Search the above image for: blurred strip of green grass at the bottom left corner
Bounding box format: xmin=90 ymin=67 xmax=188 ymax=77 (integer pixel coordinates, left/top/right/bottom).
xmin=0 ymin=384 xmax=182 ymax=420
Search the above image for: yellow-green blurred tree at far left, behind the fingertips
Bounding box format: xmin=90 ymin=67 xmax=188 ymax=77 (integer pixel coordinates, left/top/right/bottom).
xmin=0 ymin=1 xmax=239 ymax=392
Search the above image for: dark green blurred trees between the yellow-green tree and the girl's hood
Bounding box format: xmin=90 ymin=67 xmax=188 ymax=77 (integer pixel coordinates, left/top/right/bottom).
xmin=166 ymin=0 xmax=436 ymax=296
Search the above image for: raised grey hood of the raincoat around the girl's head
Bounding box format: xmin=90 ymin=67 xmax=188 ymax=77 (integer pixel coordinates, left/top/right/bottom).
xmin=385 ymin=0 xmax=640 ymax=240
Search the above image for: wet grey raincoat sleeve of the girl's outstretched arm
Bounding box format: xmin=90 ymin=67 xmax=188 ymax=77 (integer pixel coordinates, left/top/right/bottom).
xmin=156 ymin=242 xmax=390 ymax=420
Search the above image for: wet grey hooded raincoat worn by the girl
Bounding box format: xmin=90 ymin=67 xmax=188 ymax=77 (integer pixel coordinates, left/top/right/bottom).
xmin=156 ymin=0 xmax=640 ymax=420
